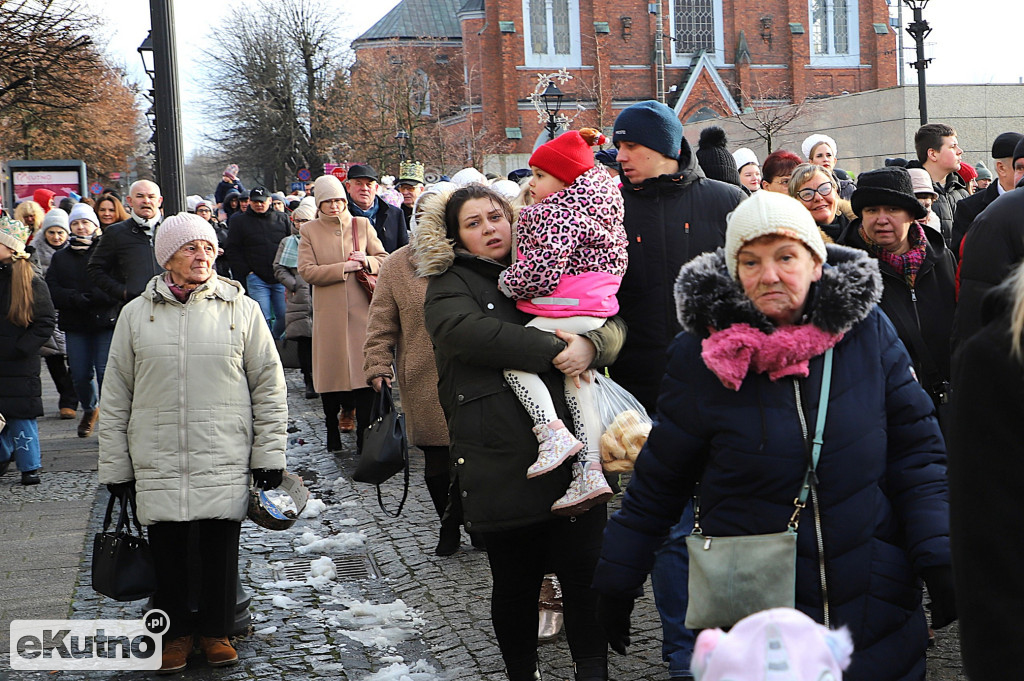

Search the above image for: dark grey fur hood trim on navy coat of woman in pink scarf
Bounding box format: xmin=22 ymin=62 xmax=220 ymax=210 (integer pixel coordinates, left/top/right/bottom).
xmin=676 ymin=245 xmax=882 ymax=338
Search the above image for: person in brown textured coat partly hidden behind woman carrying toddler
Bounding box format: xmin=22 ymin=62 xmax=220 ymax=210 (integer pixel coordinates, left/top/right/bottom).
xmin=362 ymin=188 xmax=462 ymax=556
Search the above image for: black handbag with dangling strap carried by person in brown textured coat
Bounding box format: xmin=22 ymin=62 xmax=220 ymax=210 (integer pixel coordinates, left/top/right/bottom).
xmin=352 ymin=381 xmax=409 ymax=517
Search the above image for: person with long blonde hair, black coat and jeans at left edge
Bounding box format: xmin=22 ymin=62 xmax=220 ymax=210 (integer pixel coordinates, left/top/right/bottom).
xmin=0 ymin=215 xmax=55 ymax=484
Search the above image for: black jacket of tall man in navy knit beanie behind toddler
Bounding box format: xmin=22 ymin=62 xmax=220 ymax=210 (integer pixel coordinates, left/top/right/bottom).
xmin=610 ymin=138 xmax=746 ymax=412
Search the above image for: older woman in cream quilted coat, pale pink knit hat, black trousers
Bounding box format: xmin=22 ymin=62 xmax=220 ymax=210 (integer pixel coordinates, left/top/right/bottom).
xmin=99 ymin=213 xmax=288 ymax=672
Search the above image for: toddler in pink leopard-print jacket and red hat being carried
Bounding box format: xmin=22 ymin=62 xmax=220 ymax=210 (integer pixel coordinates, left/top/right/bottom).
xmin=499 ymin=128 xmax=627 ymax=515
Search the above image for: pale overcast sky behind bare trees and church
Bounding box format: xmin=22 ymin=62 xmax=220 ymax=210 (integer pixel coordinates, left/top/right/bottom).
xmin=86 ymin=0 xmax=1024 ymax=154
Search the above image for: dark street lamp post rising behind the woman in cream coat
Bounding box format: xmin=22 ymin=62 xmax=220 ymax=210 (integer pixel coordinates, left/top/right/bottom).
xmin=138 ymin=0 xmax=185 ymax=215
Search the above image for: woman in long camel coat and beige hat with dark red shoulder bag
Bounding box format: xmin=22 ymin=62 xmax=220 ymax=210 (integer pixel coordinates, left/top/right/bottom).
xmin=299 ymin=175 xmax=387 ymax=452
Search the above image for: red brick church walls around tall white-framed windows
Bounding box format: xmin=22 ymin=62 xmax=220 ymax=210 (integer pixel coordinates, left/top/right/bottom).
xmin=360 ymin=0 xmax=897 ymax=164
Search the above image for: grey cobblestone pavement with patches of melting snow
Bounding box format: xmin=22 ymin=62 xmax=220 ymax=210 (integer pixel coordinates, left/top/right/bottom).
xmin=0 ymin=371 xmax=965 ymax=681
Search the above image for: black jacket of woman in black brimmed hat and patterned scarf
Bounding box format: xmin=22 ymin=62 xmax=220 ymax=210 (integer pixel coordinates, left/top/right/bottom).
xmin=846 ymin=220 xmax=956 ymax=407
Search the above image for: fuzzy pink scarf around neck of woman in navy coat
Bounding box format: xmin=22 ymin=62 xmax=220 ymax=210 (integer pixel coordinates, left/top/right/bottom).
xmin=700 ymin=324 xmax=843 ymax=390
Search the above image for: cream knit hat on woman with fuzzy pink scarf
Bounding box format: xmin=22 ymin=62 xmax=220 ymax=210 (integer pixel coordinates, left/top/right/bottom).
xmin=725 ymin=191 xmax=827 ymax=279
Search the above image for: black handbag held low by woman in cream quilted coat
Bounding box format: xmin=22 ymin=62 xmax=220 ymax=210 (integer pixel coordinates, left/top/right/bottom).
xmin=92 ymin=491 xmax=157 ymax=601
